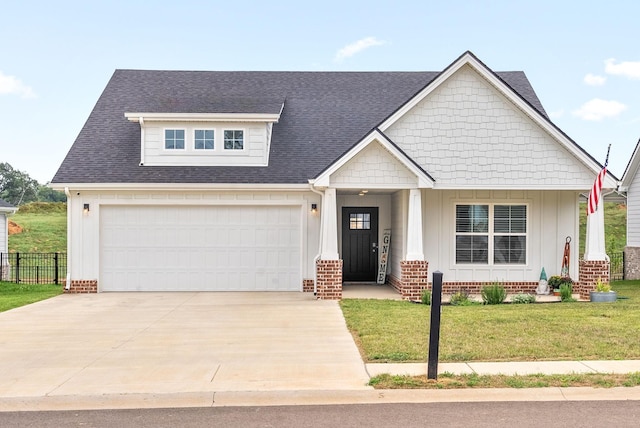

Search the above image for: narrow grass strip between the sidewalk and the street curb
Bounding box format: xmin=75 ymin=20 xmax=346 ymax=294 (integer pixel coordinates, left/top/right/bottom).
xmin=369 ymin=372 xmax=640 ymax=389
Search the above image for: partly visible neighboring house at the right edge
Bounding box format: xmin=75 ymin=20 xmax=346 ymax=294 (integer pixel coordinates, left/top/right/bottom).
xmin=619 ymin=140 xmax=640 ymax=279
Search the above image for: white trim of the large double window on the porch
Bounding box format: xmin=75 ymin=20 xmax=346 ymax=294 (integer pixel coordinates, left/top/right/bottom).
xmin=452 ymin=201 xmax=531 ymax=268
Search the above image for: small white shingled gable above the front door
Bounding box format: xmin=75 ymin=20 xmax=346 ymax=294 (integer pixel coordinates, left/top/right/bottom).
xmin=330 ymin=141 xmax=418 ymax=189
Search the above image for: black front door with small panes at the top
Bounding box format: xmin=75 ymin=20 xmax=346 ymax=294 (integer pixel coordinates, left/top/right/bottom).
xmin=342 ymin=207 xmax=378 ymax=281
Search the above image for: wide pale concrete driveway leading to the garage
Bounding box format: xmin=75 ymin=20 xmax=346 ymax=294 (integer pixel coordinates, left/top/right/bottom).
xmin=0 ymin=292 xmax=370 ymax=398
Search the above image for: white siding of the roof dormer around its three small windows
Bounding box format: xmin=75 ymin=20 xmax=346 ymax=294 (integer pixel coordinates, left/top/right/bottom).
xmin=141 ymin=122 xmax=271 ymax=166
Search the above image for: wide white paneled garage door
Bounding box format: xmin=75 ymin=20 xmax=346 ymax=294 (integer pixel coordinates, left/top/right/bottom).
xmin=99 ymin=206 xmax=302 ymax=291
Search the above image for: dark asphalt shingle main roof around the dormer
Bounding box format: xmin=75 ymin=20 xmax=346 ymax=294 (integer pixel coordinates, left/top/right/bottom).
xmin=52 ymin=66 xmax=546 ymax=183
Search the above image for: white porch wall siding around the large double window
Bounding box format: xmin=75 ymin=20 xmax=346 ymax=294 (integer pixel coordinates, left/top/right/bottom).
xmin=423 ymin=190 xmax=579 ymax=281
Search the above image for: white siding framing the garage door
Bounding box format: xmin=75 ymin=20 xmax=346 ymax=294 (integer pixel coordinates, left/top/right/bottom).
xmin=67 ymin=190 xmax=322 ymax=287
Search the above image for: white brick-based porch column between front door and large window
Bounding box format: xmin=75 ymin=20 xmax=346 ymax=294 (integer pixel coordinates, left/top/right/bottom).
xmin=399 ymin=189 xmax=429 ymax=301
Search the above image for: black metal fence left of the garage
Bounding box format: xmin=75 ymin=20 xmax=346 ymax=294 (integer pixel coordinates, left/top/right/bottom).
xmin=0 ymin=253 xmax=67 ymax=284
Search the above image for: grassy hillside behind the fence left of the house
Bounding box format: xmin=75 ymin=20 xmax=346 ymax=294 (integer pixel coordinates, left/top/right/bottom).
xmin=9 ymin=203 xmax=67 ymax=253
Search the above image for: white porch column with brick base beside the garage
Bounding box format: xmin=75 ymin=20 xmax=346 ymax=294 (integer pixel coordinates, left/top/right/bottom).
xmin=316 ymin=188 xmax=342 ymax=300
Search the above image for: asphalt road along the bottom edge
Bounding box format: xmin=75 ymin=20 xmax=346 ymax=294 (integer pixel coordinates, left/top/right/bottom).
xmin=0 ymin=401 xmax=640 ymax=428
